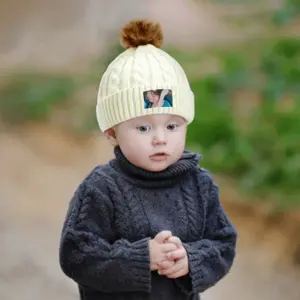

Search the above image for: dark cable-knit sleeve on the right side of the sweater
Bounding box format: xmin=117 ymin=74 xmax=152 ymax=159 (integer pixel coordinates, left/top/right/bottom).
xmin=177 ymin=170 xmax=237 ymax=293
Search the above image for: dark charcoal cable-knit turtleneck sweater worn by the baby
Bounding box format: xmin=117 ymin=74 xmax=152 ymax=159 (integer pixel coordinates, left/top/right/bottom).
xmin=59 ymin=147 xmax=237 ymax=300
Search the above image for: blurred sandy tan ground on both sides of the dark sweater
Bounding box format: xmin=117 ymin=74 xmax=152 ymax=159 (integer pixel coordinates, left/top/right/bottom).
xmin=0 ymin=126 xmax=300 ymax=300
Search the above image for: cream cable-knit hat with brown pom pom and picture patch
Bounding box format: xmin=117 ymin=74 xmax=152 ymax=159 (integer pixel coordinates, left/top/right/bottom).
xmin=96 ymin=20 xmax=194 ymax=132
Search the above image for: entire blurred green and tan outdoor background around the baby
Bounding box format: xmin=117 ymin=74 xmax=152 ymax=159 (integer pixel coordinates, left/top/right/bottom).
xmin=0 ymin=0 xmax=300 ymax=300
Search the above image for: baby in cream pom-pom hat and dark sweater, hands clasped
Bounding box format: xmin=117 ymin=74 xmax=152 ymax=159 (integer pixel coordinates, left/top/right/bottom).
xmin=59 ymin=20 xmax=237 ymax=300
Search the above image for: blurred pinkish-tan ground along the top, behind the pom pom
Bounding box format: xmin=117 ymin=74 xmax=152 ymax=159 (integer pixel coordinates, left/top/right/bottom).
xmin=0 ymin=0 xmax=276 ymax=70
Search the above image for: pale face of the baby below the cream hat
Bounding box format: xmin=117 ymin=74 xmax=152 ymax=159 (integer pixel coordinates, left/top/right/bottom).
xmin=115 ymin=114 xmax=187 ymax=172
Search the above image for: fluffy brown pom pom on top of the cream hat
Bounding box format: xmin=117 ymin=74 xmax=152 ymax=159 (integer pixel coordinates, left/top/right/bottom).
xmin=121 ymin=20 xmax=163 ymax=49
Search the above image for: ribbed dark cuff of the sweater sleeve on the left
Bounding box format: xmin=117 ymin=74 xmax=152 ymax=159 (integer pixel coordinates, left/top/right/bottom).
xmin=127 ymin=238 xmax=151 ymax=293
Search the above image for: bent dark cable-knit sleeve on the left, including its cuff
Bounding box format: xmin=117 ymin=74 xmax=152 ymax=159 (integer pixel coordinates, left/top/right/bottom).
xmin=59 ymin=176 xmax=151 ymax=293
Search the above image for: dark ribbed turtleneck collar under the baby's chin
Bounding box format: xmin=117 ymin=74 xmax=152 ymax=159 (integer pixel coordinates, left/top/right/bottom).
xmin=110 ymin=146 xmax=200 ymax=187
